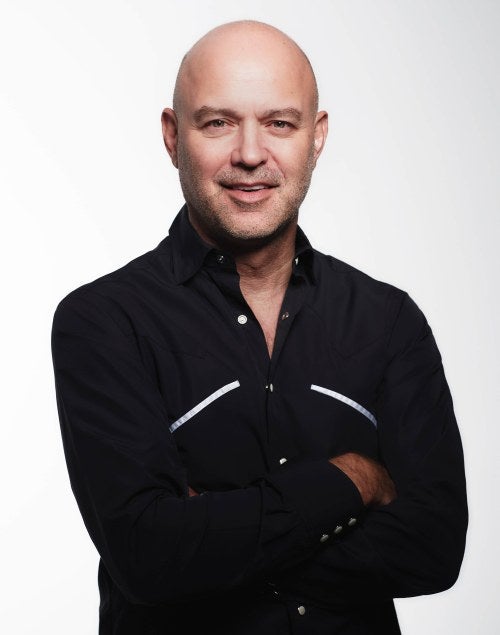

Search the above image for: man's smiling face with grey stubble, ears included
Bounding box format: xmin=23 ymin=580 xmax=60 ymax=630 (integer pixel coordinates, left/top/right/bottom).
xmin=163 ymin=28 xmax=326 ymax=249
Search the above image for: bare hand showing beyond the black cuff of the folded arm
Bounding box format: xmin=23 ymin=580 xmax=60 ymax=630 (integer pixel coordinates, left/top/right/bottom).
xmin=330 ymin=452 xmax=396 ymax=506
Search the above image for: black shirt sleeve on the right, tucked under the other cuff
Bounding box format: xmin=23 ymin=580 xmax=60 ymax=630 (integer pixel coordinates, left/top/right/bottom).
xmin=272 ymin=294 xmax=467 ymax=607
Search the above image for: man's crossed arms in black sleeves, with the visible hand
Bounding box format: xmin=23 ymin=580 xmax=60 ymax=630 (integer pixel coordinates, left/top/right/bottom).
xmin=53 ymin=292 xmax=467 ymax=606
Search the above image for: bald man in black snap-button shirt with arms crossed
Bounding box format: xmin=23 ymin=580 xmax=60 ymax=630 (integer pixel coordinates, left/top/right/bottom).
xmin=53 ymin=22 xmax=467 ymax=635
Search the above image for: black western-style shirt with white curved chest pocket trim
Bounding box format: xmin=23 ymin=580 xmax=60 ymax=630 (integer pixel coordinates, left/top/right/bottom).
xmin=52 ymin=209 xmax=467 ymax=635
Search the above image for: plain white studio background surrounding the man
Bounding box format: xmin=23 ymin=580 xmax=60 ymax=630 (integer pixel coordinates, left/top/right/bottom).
xmin=0 ymin=0 xmax=500 ymax=635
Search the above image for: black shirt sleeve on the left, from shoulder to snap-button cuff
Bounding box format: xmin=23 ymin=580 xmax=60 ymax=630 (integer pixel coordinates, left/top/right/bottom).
xmin=52 ymin=288 xmax=362 ymax=604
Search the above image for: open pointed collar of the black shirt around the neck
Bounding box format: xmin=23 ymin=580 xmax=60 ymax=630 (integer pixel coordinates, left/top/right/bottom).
xmin=169 ymin=205 xmax=314 ymax=284
